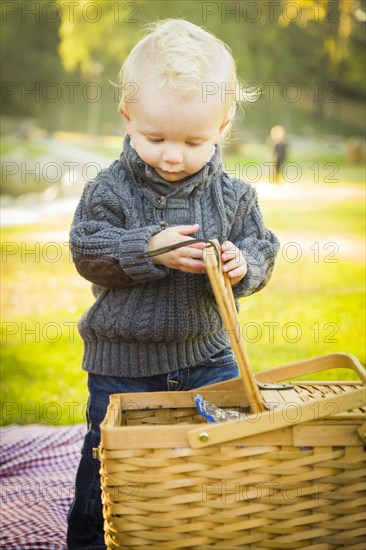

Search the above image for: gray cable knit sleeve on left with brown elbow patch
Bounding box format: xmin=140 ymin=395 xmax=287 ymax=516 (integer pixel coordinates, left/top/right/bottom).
xmin=70 ymin=176 xmax=168 ymax=289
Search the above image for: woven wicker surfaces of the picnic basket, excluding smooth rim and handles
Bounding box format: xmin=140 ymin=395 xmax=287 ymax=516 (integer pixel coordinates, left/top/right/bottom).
xmin=101 ymin=383 xmax=366 ymax=550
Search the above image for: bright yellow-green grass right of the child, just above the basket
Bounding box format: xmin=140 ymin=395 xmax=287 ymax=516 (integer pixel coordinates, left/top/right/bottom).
xmin=240 ymin=253 xmax=365 ymax=379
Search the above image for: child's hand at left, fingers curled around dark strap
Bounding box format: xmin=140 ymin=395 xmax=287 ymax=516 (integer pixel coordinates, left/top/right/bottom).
xmin=148 ymin=223 xmax=206 ymax=273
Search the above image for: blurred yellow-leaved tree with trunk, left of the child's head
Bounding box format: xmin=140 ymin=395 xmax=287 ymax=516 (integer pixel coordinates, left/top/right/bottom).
xmin=58 ymin=0 xmax=139 ymax=134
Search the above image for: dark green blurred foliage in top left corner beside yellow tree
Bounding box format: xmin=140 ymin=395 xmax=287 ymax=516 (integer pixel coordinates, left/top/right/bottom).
xmin=0 ymin=0 xmax=65 ymax=132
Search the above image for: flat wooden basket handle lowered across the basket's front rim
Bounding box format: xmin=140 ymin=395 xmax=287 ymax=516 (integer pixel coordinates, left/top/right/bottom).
xmin=187 ymin=387 xmax=366 ymax=449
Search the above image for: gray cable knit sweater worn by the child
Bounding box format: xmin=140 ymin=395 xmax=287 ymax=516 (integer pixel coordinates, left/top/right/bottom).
xmin=70 ymin=136 xmax=279 ymax=378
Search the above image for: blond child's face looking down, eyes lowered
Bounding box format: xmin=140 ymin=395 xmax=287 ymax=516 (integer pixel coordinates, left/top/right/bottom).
xmin=121 ymin=81 xmax=227 ymax=183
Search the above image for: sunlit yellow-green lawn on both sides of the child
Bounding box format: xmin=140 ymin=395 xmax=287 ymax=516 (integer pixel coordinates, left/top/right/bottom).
xmin=2 ymin=183 xmax=365 ymax=430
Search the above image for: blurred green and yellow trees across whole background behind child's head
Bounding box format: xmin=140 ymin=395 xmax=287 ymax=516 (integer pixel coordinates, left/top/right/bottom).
xmin=0 ymin=0 xmax=366 ymax=133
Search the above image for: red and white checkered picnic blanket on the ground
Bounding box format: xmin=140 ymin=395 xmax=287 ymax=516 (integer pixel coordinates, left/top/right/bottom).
xmin=0 ymin=424 xmax=86 ymax=550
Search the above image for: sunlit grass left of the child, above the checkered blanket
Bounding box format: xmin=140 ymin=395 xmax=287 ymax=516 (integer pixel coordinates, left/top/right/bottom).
xmin=2 ymin=219 xmax=93 ymax=424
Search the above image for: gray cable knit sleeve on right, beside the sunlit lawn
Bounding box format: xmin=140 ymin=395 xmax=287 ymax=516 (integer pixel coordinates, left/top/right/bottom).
xmin=228 ymin=182 xmax=279 ymax=297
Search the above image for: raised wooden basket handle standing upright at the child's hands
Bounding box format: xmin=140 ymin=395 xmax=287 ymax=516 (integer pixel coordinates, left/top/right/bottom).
xmin=203 ymin=240 xmax=265 ymax=411
